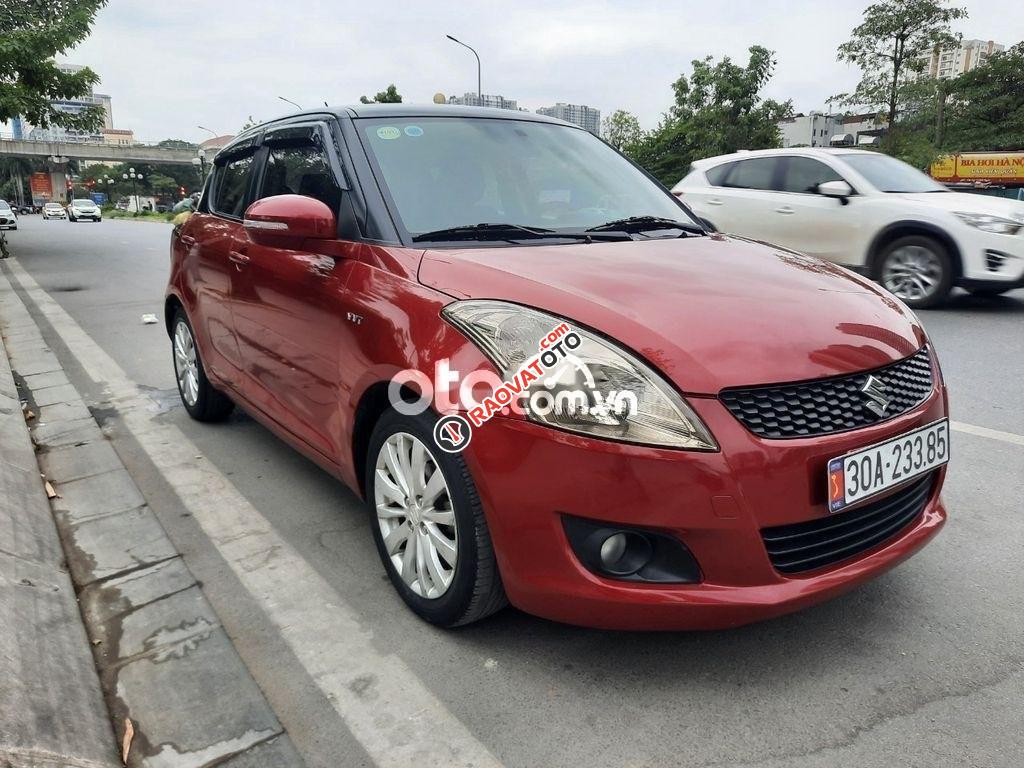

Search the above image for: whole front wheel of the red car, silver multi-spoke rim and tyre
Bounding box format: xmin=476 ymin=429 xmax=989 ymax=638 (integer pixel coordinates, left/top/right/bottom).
xmin=365 ymin=411 xmax=508 ymax=627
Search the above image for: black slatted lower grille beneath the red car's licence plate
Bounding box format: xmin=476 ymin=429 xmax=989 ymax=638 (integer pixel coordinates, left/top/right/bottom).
xmin=761 ymin=471 xmax=935 ymax=573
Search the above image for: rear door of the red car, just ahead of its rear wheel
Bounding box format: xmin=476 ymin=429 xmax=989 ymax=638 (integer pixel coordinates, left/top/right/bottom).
xmin=190 ymin=143 xmax=256 ymax=376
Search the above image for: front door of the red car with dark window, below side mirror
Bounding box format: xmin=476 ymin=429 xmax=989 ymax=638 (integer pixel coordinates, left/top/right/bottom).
xmin=232 ymin=123 xmax=347 ymax=458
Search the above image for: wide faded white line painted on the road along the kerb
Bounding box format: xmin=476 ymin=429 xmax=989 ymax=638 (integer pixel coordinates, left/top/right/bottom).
xmin=0 ymin=259 xmax=501 ymax=768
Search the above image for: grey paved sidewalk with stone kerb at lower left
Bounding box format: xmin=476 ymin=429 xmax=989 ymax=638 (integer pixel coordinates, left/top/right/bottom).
xmin=0 ymin=262 xmax=302 ymax=768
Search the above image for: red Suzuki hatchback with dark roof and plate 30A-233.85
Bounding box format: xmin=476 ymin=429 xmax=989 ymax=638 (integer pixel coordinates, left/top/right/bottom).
xmin=166 ymin=104 xmax=949 ymax=629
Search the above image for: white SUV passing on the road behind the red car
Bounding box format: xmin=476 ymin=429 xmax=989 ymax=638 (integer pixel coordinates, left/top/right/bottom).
xmin=672 ymin=148 xmax=1024 ymax=308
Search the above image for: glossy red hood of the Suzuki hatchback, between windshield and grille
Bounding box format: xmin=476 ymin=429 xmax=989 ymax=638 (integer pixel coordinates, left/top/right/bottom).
xmin=419 ymin=234 xmax=926 ymax=394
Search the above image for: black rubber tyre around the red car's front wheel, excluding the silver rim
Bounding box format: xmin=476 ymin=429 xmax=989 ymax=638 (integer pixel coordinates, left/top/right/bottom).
xmin=365 ymin=410 xmax=508 ymax=628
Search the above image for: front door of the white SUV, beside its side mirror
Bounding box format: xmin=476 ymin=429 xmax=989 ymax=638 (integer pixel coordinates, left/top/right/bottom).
xmin=773 ymin=155 xmax=864 ymax=264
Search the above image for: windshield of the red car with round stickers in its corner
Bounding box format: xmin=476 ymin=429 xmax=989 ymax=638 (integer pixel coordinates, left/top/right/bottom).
xmin=357 ymin=118 xmax=695 ymax=240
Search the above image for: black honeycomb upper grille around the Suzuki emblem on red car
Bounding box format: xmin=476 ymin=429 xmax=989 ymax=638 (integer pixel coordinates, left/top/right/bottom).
xmin=719 ymin=347 xmax=932 ymax=438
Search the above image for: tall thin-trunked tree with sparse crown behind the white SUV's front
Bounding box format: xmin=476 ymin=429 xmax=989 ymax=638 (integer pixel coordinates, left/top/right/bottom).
xmin=833 ymin=0 xmax=967 ymax=144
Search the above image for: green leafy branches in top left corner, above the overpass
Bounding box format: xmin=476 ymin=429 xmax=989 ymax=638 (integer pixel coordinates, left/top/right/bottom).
xmin=0 ymin=0 xmax=106 ymax=131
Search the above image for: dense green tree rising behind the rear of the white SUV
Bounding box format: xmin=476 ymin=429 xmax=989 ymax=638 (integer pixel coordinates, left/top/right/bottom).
xmin=630 ymin=45 xmax=793 ymax=184
